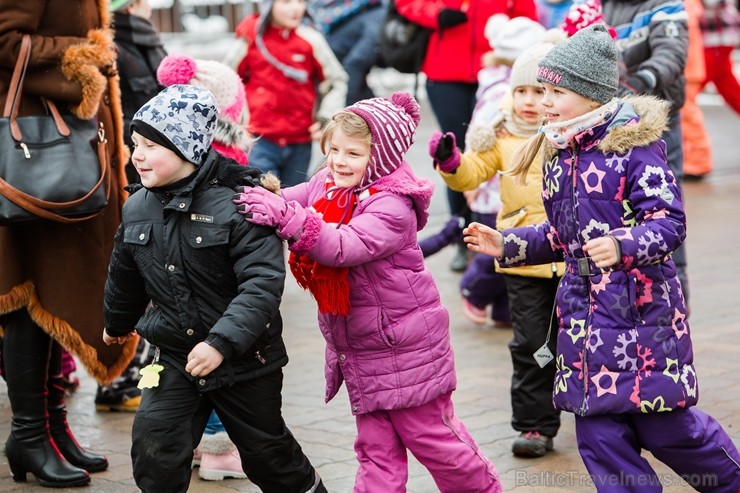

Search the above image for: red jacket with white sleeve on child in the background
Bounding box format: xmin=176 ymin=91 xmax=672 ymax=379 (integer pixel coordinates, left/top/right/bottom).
xmin=236 ymin=15 xmax=348 ymax=145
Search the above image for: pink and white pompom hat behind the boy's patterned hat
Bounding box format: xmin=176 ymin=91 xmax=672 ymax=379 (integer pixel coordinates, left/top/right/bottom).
xmin=157 ymin=54 xmax=250 ymax=164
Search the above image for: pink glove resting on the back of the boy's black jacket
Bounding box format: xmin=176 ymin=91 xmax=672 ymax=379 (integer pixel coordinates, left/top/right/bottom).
xmin=233 ymin=187 xmax=306 ymax=240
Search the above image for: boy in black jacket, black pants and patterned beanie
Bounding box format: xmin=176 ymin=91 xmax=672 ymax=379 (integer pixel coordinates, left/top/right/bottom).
xmin=103 ymin=85 xmax=326 ymax=493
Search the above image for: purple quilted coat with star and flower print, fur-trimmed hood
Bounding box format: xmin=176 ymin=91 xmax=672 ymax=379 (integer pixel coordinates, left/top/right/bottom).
xmin=502 ymin=96 xmax=698 ymax=416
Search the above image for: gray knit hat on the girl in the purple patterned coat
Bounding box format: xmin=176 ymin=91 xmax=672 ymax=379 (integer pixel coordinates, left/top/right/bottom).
xmin=537 ymin=24 xmax=619 ymax=104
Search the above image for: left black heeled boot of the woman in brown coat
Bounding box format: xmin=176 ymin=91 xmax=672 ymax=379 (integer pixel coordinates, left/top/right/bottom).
xmin=2 ymin=309 xmax=90 ymax=488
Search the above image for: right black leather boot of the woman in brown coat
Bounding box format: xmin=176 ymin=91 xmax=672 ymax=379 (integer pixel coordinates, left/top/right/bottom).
xmin=46 ymin=341 xmax=108 ymax=472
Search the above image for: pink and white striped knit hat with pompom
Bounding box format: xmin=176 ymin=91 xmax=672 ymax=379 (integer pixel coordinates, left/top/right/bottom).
xmin=345 ymin=92 xmax=421 ymax=186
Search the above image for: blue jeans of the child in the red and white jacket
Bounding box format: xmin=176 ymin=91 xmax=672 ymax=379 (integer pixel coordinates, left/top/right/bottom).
xmin=249 ymin=137 xmax=311 ymax=188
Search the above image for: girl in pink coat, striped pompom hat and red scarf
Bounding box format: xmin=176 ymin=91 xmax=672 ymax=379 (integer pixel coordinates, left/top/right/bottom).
xmin=236 ymin=93 xmax=501 ymax=493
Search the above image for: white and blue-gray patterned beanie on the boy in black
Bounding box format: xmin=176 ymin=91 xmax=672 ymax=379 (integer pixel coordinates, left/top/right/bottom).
xmin=131 ymin=84 xmax=218 ymax=166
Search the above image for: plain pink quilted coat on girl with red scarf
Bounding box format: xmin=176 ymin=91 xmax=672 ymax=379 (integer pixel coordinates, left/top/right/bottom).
xmin=282 ymin=162 xmax=456 ymax=414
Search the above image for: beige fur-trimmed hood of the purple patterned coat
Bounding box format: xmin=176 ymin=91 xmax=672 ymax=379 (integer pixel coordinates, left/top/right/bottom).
xmin=545 ymin=96 xmax=670 ymax=160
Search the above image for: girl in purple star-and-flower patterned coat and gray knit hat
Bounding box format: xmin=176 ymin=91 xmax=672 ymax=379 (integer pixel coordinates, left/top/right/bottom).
xmin=465 ymin=25 xmax=740 ymax=493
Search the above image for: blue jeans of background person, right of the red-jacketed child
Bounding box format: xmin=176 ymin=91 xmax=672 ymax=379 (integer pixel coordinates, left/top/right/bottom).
xmin=326 ymin=5 xmax=385 ymax=106
